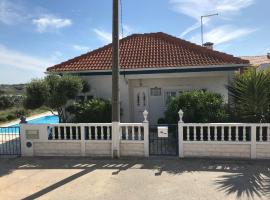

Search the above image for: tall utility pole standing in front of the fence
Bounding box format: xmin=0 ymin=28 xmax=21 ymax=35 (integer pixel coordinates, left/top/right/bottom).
xmin=112 ymin=0 xmax=120 ymax=158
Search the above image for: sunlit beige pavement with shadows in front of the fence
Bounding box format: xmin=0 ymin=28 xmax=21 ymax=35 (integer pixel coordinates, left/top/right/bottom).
xmin=0 ymin=158 xmax=270 ymax=200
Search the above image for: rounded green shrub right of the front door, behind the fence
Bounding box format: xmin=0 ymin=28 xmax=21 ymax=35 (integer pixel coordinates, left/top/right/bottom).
xmin=165 ymin=90 xmax=228 ymax=124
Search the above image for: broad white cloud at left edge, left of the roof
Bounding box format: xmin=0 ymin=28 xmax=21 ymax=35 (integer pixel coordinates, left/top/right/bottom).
xmin=0 ymin=45 xmax=54 ymax=72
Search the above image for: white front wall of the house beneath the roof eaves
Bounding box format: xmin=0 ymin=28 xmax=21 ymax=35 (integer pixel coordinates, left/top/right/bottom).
xmin=80 ymin=72 xmax=234 ymax=124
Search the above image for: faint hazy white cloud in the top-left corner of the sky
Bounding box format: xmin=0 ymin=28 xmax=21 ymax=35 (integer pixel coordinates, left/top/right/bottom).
xmin=0 ymin=0 xmax=27 ymax=25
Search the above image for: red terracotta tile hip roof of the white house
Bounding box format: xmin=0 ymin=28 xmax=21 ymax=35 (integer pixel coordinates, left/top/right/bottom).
xmin=47 ymin=32 xmax=249 ymax=72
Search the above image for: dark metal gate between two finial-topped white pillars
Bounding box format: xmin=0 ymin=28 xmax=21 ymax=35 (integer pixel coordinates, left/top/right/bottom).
xmin=149 ymin=124 xmax=178 ymax=156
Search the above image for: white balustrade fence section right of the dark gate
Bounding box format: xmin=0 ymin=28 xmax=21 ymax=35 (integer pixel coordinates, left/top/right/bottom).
xmin=178 ymin=111 xmax=270 ymax=159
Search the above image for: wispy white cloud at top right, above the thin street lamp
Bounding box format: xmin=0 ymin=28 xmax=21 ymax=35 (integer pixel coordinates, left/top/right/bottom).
xmin=170 ymin=0 xmax=255 ymax=37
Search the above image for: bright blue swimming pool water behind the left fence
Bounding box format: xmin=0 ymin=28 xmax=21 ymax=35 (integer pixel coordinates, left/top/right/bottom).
xmin=0 ymin=115 xmax=59 ymax=134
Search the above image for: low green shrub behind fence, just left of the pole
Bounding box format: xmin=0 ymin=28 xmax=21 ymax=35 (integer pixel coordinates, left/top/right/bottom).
xmin=67 ymin=99 xmax=112 ymax=123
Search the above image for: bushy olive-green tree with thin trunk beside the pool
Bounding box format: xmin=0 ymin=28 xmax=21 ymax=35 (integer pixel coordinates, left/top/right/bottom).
xmin=24 ymin=75 xmax=83 ymax=122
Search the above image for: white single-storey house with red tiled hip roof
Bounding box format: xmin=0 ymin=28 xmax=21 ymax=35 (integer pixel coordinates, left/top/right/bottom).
xmin=47 ymin=32 xmax=249 ymax=124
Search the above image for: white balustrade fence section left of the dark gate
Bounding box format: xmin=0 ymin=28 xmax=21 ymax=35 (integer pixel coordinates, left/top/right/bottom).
xmin=21 ymin=112 xmax=149 ymax=157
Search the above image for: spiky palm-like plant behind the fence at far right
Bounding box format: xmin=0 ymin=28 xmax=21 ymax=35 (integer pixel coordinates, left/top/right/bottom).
xmin=227 ymin=68 xmax=270 ymax=123
